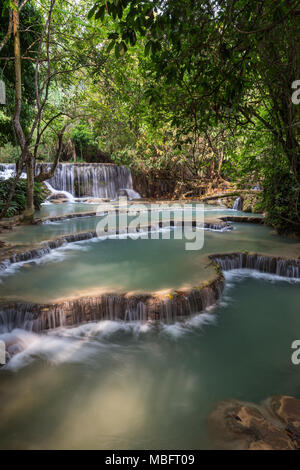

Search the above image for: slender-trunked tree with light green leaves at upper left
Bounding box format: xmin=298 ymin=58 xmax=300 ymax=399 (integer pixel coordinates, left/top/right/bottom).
xmin=0 ymin=0 xmax=108 ymax=221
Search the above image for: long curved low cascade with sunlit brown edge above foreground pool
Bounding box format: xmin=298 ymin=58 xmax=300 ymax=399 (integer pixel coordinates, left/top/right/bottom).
xmin=0 ymin=275 xmax=224 ymax=333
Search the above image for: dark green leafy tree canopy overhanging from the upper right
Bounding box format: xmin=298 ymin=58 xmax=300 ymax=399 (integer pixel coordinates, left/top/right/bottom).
xmin=90 ymin=0 xmax=300 ymax=230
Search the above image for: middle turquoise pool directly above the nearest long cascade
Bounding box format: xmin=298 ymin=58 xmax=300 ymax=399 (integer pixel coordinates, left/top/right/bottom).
xmin=0 ymin=218 xmax=300 ymax=303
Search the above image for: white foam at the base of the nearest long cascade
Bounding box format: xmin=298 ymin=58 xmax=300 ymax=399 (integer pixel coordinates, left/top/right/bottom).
xmin=0 ymin=313 xmax=216 ymax=371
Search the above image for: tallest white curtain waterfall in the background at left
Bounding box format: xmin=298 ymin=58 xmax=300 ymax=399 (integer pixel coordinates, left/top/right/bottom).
xmin=0 ymin=163 xmax=140 ymax=200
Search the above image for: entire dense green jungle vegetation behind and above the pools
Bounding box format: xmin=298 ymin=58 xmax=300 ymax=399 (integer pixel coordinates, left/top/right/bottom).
xmin=0 ymin=0 xmax=300 ymax=234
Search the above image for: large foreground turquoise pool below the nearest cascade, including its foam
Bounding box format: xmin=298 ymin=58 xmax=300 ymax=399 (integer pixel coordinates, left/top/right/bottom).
xmin=0 ymin=272 xmax=300 ymax=449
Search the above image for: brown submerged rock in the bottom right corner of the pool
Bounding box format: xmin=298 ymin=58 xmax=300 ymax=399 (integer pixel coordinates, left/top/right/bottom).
xmin=208 ymin=395 xmax=300 ymax=450
